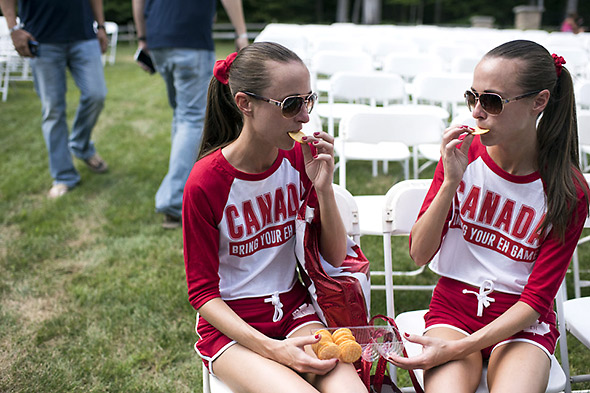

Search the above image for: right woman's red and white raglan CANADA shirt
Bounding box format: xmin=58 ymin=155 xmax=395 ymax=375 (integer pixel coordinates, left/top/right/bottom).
xmin=419 ymin=137 xmax=587 ymax=316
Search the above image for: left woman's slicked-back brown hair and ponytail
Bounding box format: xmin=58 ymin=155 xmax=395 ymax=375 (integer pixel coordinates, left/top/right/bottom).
xmin=198 ymin=42 xmax=303 ymax=159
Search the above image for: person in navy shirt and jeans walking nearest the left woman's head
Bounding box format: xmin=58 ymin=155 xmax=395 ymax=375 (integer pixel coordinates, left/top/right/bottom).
xmin=132 ymin=0 xmax=248 ymax=229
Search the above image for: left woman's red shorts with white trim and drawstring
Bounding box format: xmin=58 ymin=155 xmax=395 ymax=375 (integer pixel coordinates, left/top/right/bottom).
xmin=195 ymin=283 xmax=322 ymax=374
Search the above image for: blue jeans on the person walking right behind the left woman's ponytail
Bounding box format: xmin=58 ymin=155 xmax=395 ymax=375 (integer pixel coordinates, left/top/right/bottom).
xmin=150 ymin=48 xmax=215 ymax=217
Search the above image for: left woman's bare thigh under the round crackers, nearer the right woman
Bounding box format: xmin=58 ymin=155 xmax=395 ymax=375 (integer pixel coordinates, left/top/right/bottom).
xmin=290 ymin=323 xmax=367 ymax=393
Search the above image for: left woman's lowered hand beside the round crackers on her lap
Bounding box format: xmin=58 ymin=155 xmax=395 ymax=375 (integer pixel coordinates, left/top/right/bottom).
xmin=273 ymin=335 xmax=338 ymax=375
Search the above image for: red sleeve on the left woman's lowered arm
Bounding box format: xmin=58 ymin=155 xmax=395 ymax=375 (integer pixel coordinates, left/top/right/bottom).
xmin=182 ymin=153 xmax=229 ymax=309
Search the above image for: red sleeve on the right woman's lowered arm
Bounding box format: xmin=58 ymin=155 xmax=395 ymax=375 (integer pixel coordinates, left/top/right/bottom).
xmin=520 ymin=174 xmax=588 ymax=316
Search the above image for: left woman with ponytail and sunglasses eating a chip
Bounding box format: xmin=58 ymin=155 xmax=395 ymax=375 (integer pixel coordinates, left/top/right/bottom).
xmin=183 ymin=42 xmax=366 ymax=393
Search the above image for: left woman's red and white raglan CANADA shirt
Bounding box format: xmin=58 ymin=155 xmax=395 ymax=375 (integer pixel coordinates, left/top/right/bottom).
xmin=182 ymin=144 xmax=312 ymax=309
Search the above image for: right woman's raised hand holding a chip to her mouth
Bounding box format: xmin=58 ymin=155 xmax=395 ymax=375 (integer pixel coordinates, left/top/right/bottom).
xmin=440 ymin=125 xmax=475 ymax=185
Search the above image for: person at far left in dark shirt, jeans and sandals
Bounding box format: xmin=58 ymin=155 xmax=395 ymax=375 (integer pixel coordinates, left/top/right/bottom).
xmin=0 ymin=0 xmax=108 ymax=198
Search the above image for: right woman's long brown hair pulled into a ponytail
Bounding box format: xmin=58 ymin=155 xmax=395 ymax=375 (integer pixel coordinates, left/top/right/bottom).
xmin=484 ymin=40 xmax=588 ymax=241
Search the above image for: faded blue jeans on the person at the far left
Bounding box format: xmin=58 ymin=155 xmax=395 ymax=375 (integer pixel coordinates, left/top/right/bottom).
xmin=31 ymin=39 xmax=107 ymax=187
